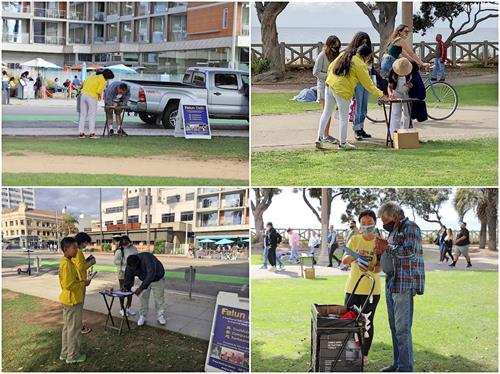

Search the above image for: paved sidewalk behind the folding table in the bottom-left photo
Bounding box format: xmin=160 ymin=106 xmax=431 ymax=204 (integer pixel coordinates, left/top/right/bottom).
xmin=2 ymin=269 xmax=216 ymax=340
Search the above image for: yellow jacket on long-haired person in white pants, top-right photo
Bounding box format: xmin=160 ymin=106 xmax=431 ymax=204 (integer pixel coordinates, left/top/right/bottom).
xmin=326 ymin=52 xmax=384 ymax=100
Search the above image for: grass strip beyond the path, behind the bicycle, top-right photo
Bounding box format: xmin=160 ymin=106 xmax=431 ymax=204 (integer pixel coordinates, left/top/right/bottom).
xmin=252 ymin=83 xmax=498 ymax=116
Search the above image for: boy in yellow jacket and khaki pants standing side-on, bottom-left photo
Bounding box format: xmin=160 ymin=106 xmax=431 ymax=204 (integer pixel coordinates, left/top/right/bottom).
xmin=59 ymin=237 xmax=90 ymax=364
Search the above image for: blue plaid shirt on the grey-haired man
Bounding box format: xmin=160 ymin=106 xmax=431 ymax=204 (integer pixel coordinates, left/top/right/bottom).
xmin=387 ymin=218 xmax=425 ymax=295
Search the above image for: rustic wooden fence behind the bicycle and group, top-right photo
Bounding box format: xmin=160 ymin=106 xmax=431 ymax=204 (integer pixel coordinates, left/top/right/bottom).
xmin=252 ymin=40 xmax=498 ymax=67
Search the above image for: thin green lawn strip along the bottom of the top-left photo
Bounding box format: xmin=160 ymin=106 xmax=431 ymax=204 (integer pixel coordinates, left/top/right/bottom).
xmin=2 ymin=173 xmax=248 ymax=186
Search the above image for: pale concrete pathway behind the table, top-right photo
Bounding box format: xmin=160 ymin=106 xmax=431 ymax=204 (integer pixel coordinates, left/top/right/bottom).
xmin=251 ymin=107 xmax=498 ymax=152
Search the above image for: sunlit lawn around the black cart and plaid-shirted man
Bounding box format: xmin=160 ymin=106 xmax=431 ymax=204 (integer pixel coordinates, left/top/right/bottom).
xmin=252 ymin=271 xmax=498 ymax=372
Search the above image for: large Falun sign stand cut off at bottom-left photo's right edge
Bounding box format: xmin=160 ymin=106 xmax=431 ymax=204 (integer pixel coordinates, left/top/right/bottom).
xmin=205 ymin=291 xmax=250 ymax=372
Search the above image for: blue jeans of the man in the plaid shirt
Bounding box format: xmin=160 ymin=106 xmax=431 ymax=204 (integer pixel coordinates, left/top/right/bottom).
xmin=385 ymin=281 xmax=414 ymax=372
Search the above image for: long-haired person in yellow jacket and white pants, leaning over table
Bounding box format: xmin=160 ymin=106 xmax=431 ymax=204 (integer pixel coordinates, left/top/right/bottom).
xmin=316 ymin=44 xmax=384 ymax=150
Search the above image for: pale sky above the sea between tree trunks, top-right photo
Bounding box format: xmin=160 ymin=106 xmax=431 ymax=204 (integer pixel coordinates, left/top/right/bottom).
xmin=251 ymin=1 xmax=498 ymax=28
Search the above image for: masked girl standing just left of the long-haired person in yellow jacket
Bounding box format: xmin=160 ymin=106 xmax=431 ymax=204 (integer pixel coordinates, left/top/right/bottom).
xmin=313 ymin=35 xmax=341 ymax=144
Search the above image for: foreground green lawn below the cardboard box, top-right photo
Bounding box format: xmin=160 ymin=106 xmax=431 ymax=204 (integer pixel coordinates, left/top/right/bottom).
xmin=252 ymin=138 xmax=498 ymax=186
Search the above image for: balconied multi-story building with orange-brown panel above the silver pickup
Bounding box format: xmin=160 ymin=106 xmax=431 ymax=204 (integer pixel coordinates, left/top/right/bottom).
xmin=2 ymin=1 xmax=250 ymax=75
